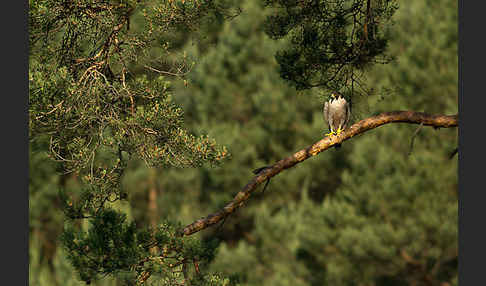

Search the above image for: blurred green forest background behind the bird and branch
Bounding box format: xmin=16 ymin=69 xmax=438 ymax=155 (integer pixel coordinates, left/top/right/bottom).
xmin=29 ymin=0 xmax=458 ymax=286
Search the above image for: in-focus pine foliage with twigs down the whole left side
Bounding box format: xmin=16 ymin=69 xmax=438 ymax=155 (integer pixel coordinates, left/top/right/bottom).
xmin=29 ymin=0 xmax=233 ymax=284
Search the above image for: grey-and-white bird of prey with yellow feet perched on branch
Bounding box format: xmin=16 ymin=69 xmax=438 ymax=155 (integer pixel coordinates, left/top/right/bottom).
xmin=323 ymin=92 xmax=351 ymax=148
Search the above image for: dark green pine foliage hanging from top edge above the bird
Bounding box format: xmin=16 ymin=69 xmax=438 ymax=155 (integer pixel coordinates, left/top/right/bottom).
xmin=264 ymin=0 xmax=398 ymax=92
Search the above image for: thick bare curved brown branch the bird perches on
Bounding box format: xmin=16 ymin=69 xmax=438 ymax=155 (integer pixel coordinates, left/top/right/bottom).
xmin=182 ymin=111 xmax=459 ymax=235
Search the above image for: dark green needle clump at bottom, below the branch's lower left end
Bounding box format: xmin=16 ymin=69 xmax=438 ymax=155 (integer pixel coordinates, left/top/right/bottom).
xmin=61 ymin=208 xmax=224 ymax=285
